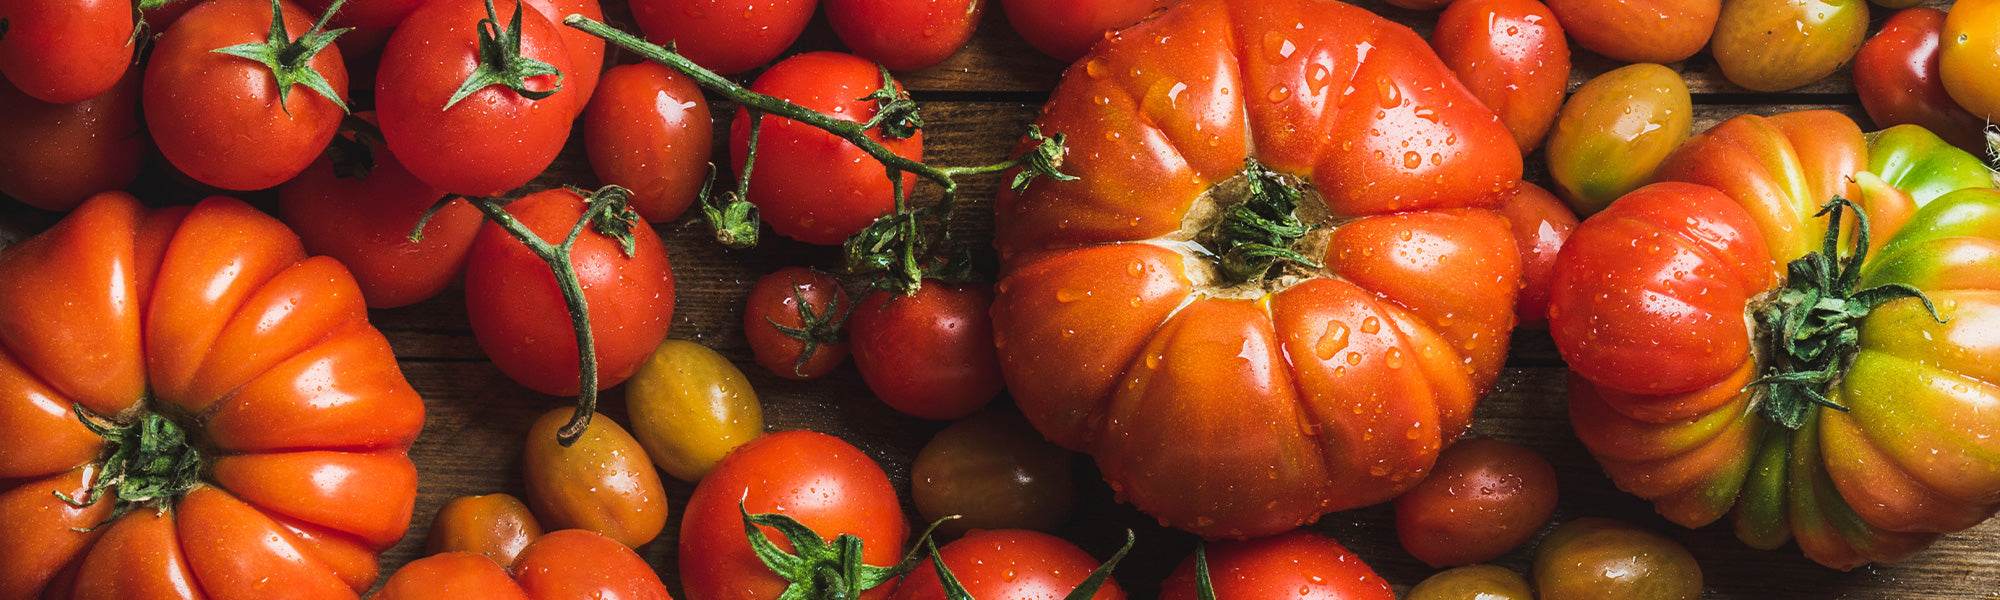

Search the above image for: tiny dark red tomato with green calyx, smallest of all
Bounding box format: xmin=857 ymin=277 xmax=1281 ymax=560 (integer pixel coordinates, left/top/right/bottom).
xmin=744 ymin=266 xmax=852 ymax=380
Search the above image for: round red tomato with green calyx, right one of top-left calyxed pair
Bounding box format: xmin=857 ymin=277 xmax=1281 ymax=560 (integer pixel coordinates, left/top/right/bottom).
xmin=376 ymin=0 xmax=582 ymax=196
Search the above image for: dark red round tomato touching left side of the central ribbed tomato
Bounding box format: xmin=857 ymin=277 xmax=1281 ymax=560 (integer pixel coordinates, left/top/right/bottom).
xmin=848 ymin=280 xmax=1004 ymax=420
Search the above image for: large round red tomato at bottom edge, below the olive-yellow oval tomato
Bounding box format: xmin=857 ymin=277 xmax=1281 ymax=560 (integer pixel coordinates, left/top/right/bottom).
xmin=680 ymin=432 xmax=910 ymax=600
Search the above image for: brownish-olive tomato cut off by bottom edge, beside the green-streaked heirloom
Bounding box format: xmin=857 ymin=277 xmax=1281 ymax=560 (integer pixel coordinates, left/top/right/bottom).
xmin=1534 ymin=518 xmax=1702 ymax=600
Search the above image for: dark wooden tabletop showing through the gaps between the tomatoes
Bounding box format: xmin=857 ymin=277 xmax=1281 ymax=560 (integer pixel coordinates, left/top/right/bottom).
xmin=11 ymin=0 xmax=2000 ymax=600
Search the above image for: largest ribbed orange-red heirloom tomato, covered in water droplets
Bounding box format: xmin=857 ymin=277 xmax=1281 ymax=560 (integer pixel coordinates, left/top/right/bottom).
xmin=994 ymin=0 xmax=1520 ymax=538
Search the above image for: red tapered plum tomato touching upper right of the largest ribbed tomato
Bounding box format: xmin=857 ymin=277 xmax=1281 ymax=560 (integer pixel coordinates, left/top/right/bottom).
xmin=1430 ymin=0 xmax=1570 ymax=154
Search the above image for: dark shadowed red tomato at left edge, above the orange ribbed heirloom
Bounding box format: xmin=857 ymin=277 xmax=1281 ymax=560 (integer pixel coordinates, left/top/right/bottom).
xmin=0 ymin=74 xmax=146 ymax=210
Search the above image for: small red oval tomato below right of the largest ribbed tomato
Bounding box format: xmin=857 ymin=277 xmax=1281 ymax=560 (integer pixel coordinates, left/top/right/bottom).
xmin=1396 ymin=440 xmax=1556 ymax=566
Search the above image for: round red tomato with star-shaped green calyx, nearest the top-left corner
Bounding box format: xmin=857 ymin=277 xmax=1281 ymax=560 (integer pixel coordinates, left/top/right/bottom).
xmin=144 ymin=0 xmax=348 ymax=190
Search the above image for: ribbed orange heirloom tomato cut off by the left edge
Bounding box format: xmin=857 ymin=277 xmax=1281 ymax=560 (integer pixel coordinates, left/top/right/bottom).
xmin=0 ymin=192 xmax=424 ymax=600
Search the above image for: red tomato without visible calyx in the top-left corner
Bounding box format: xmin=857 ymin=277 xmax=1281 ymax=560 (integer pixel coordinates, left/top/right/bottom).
xmin=0 ymin=0 xmax=133 ymax=104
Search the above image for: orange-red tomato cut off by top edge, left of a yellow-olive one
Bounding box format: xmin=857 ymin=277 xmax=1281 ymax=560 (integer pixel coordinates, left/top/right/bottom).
xmin=1548 ymin=0 xmax=1722 ymax=64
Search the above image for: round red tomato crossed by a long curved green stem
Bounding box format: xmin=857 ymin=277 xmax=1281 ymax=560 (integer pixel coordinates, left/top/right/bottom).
xmin=466 ymin=188 xmax=674 ymax=396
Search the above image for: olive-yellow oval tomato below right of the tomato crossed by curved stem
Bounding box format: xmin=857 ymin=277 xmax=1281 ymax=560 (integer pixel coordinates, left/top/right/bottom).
xmin=626 ymin=340 xmax=764 ymax=482
